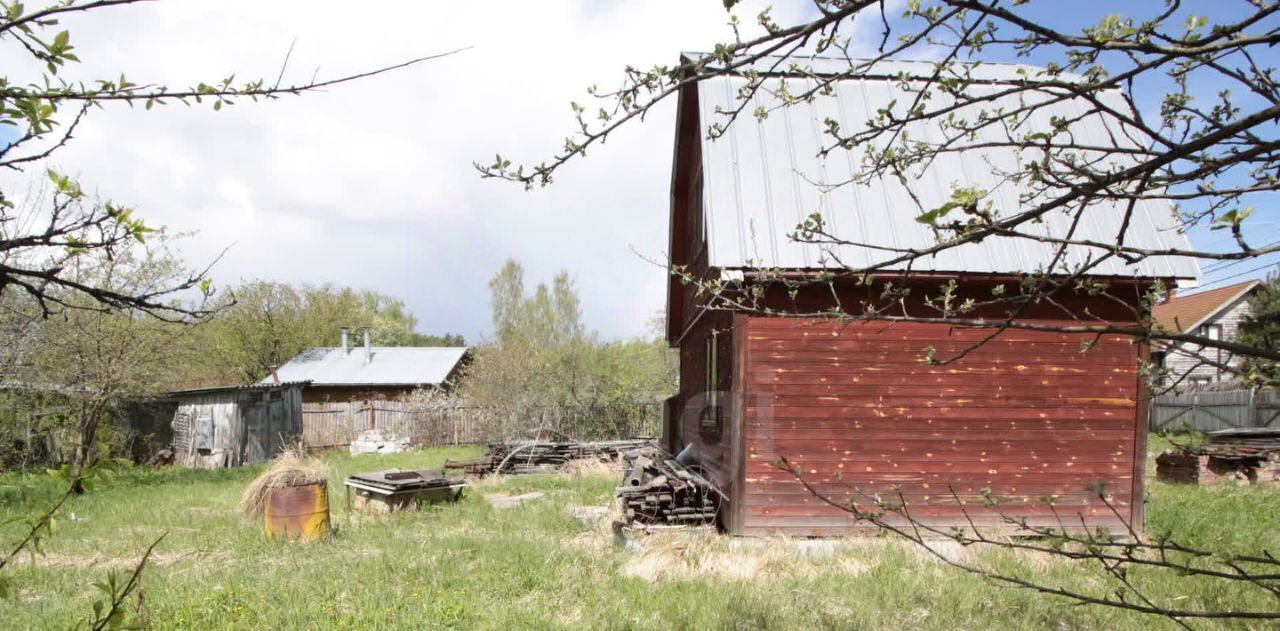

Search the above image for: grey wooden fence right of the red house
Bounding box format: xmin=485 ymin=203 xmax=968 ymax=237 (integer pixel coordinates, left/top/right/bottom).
xmin=1148 ymin=390 xmax=1280 ymax=431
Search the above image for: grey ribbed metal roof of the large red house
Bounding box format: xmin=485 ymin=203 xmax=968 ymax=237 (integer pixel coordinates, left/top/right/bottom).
xmin=685 ymin=54 xmax=1199 ymax=280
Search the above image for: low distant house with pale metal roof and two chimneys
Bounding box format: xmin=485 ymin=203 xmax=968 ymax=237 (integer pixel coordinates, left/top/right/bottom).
xmin=260 ymin=329 xmax=467 ymax=403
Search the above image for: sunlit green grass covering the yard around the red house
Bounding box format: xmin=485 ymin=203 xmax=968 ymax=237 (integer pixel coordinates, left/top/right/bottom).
xmin=0 ymin=440 xmax=1280 ymax=630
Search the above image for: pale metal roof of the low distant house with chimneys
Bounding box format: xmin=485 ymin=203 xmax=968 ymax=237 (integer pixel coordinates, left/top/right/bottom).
xmin=260 ymin=346 xmax=467 ymax=387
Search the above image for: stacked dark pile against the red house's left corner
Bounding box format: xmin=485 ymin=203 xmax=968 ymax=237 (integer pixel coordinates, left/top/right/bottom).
xmin=618 ymin=448 xmax=721 ymax=526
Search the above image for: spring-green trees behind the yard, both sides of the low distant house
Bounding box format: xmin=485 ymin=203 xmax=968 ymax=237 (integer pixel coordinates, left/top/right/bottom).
xmin=0 ymin=236 xmax=677 ymax=465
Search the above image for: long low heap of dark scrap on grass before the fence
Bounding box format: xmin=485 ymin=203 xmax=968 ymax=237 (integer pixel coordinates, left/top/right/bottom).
xmin=444 ymin=438 xmax=653 ymax=475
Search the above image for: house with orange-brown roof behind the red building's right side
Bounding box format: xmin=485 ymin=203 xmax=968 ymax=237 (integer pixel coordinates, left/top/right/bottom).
xmin=1151 ymin=280 xmax=1262 ymax=387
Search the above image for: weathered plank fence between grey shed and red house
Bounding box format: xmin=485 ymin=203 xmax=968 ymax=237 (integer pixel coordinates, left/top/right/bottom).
xmin=302 ymin=401 xmax=662 ymax=449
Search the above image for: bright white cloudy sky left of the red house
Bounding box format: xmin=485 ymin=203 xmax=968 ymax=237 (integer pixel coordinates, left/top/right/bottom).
xmin=17 ymin=0 xmax=849 ymax=340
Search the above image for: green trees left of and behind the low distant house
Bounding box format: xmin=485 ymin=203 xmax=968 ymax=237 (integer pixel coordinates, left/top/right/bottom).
xmin=0 ymin=236 xmax=466 ymax=465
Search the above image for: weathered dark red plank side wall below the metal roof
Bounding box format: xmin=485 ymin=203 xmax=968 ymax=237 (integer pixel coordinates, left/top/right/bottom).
xmin=732 ymin=316 xmax=1144 ymax=536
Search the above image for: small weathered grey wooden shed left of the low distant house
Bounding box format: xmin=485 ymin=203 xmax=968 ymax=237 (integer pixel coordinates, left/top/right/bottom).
xmin=170 ymin=381 xmax=306 ymax=468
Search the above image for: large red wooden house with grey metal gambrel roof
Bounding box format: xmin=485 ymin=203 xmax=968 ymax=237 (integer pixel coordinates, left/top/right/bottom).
xmin=666 ymin=58 xmax=1199 ymax=536
